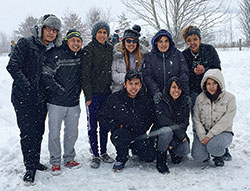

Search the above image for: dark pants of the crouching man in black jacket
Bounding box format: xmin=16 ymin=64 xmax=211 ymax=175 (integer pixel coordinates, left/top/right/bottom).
xmin=111 ymin=129 xmax=156 ymax=163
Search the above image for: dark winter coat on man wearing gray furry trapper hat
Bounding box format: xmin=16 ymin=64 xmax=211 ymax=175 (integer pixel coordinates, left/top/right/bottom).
xmin=7 ymin=28 xmax=60 ymax=103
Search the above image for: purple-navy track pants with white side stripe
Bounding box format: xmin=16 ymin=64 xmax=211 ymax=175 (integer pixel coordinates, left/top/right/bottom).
xmin=87 ymin=95 xmax=108 ymax=157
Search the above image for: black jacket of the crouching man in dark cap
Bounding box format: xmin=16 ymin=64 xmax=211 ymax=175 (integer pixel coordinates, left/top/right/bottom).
xmin=99 ymin=89 xmax=154 ymax=137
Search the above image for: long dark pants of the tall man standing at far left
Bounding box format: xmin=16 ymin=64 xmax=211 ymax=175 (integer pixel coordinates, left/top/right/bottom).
xmin=12 ymin=100 xmax=47 ymax=169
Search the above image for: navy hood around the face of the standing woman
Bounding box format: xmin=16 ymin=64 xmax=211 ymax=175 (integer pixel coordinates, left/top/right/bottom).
xmin=151 ymin=29 xmax=175 ymax=53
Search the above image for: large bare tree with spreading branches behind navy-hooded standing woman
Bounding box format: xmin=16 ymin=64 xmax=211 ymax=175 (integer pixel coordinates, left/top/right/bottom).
xmin=122 ymin=0 xmax=231 ymax=47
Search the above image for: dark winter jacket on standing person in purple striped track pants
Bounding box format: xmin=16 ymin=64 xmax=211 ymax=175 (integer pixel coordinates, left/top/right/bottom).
xmin=82 ymin=38 xmax=113 ymax=101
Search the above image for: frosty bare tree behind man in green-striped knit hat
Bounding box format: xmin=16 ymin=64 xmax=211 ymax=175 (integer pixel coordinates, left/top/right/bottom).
xmin=62 ymin=11 xmax=87 ymax=44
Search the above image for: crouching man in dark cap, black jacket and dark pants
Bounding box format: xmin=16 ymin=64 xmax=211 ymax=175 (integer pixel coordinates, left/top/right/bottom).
xmin=99 ymin=70 xmax=156 ymax=172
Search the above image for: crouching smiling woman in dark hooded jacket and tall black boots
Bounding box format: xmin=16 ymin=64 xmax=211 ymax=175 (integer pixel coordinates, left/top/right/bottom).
xmin=154 ymin=77 xmax=191 ymax=174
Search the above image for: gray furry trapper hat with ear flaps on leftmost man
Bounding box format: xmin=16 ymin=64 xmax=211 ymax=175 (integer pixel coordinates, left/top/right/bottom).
xmin=35 ymin=14 xmax=62 ymax=46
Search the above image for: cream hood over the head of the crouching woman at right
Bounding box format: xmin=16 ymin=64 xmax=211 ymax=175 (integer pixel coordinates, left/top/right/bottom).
xmin=201 ymin=69 xmax=225 ymax=92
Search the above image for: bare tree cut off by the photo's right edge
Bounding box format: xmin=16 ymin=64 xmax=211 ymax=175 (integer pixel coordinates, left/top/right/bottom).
xmin=239 ymin=0 xmax=250 ymax=46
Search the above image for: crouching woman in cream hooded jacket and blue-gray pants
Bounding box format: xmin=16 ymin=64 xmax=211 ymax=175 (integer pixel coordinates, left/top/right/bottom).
xmin=192 ymin=69 xmax=236 ymax=166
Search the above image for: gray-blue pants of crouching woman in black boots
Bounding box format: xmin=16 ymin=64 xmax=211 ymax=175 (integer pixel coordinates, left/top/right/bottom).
xmin=157 ymin=127 xmax=190 ymax=156
